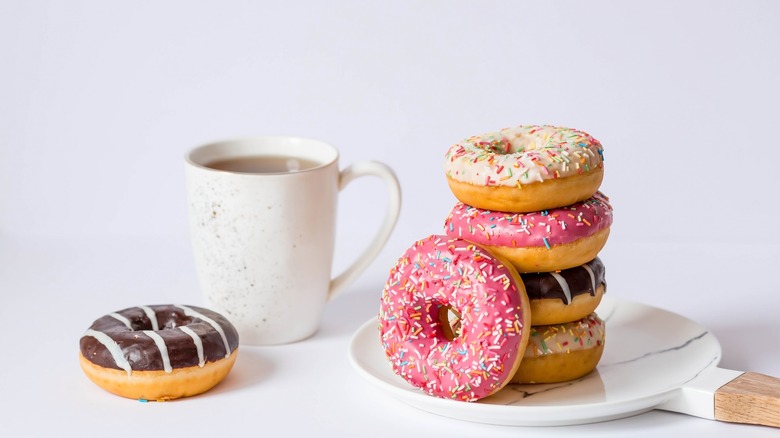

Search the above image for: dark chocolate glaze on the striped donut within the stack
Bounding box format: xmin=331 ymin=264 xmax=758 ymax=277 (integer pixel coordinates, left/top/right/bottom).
xmin=520 ymin=257 xmax=607 ymax=304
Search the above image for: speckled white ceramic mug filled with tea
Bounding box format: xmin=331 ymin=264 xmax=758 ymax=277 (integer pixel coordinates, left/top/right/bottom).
xmin=186 ymin=136 xmax=401 ymax=345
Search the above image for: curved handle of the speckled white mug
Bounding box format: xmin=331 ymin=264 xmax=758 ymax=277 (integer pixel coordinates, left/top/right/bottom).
xmin=328 ymin=161 xmax=401 ymax=300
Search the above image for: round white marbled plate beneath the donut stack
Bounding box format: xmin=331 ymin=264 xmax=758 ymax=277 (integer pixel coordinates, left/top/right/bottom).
xmin=349 ymin=297 xmax=721 ymax=426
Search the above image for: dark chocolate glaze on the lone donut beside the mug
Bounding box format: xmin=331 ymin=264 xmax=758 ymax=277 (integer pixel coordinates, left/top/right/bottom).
xmin=79 ymin=305 xmax=238 ymax=371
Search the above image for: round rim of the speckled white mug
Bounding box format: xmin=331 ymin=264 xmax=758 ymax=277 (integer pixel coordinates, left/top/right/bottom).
xmin=184 ymin=135 xmax=339 ymax=177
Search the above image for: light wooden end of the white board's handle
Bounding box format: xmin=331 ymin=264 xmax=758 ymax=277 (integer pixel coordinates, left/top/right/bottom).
xmin=715 ymin=373 xmax=780 ymax=427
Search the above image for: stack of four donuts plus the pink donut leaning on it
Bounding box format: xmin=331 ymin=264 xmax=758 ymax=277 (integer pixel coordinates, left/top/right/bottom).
xmin=378 ymin=126 xmax=612 ymax=401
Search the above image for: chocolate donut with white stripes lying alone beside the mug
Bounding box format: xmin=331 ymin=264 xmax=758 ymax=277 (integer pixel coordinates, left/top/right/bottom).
xmin=79 ymin=305 xmax=238 ymax=400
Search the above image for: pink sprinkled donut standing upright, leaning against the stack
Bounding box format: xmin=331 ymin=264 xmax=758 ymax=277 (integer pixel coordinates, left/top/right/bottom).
xmin=379 ymin=235 xmax=531 ymax=401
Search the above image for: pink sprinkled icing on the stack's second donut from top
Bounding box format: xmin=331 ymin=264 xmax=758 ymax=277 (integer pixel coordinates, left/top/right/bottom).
xmin=444 ymin=192 xmax=612 ymax=248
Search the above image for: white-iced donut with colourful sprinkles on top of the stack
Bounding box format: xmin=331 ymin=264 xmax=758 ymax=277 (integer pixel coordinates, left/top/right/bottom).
xmin=444 ymin=125 xmax=604 ymax=213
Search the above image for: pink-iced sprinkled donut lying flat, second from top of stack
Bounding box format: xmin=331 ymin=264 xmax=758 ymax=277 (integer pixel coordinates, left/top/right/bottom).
xmin=444 ymin=192 xmax=612 ymax=273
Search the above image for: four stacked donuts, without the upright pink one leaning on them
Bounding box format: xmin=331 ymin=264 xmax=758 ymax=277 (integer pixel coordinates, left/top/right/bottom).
xmin=445 ymin=125 xmax=612 ymax=383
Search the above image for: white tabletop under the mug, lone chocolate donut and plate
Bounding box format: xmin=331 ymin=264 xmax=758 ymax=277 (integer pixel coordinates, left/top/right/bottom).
xmin=0 ymin=234 xmax=780 ymax=436
